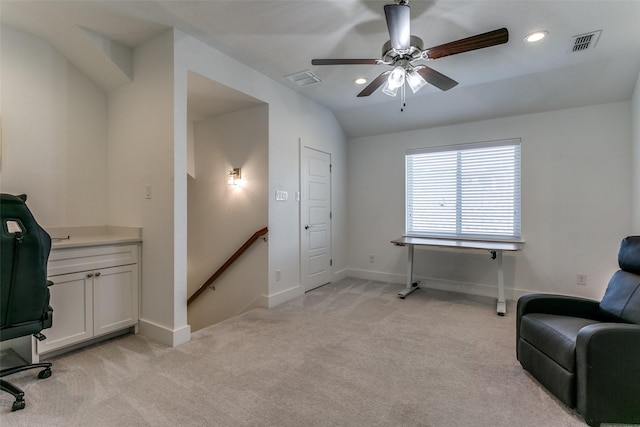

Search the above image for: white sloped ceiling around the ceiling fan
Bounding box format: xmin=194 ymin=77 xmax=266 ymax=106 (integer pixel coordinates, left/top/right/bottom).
xmin=0 ymin=0 xmax=640 ymax=137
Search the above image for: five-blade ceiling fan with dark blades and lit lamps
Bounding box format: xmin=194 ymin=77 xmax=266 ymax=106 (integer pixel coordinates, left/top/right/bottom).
xmin=311 ymin=0 xmax=509 ymax=105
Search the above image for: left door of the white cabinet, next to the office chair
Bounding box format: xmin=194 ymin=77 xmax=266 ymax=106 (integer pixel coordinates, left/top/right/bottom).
xmin=38 ymin=271 xmax=93 ymax=353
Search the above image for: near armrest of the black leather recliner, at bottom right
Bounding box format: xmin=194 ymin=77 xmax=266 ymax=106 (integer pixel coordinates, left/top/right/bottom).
xmin=576 ymin=323 xmax=640 ymax=425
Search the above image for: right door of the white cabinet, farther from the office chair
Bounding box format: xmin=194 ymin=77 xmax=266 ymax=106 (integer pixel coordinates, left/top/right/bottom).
xmin=93 ymin=264 xmax=138 ymax=336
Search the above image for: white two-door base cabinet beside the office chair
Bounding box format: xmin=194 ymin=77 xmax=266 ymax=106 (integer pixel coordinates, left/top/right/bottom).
xmin=36 ymin=244 xmax=140 ymax=355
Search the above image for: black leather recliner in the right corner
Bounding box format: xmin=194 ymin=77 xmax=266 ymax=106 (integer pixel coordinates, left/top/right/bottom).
xmin=516 ymin=236 xmax=640 ymax=426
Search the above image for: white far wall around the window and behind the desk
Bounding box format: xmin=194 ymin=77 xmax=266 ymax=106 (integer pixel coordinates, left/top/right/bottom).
xmin=347 ymin=102 xmax=633 ymax=298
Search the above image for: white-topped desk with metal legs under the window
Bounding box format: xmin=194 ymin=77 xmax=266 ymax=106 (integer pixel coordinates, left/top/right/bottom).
xmin=391 ymin=236 xmax=520 ymax=316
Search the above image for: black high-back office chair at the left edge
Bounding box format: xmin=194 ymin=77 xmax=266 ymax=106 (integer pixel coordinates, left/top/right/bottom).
xmin=0 ymin=194 xmax=53 ymax=411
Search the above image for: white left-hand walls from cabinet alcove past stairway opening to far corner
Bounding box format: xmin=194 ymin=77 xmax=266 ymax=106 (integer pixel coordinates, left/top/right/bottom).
xmin=1 ymin=27 xmax=346 ymax=345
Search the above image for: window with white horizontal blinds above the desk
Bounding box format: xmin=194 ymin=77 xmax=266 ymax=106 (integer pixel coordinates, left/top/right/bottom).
xmin=405 ymin=139 xmax=520 ymax=240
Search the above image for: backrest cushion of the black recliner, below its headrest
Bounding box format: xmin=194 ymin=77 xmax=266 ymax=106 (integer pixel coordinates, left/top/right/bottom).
xmin=600 ymin=270 xmax=640 ymax=324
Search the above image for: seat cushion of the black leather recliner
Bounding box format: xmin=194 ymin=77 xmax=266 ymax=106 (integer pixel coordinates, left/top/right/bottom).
xmin=520 ymin=313 xmax=601 ymax=372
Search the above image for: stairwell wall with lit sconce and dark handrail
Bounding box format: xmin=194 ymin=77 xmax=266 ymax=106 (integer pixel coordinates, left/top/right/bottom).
xmin=187 ymin=105 xmax=269 ymax=330
